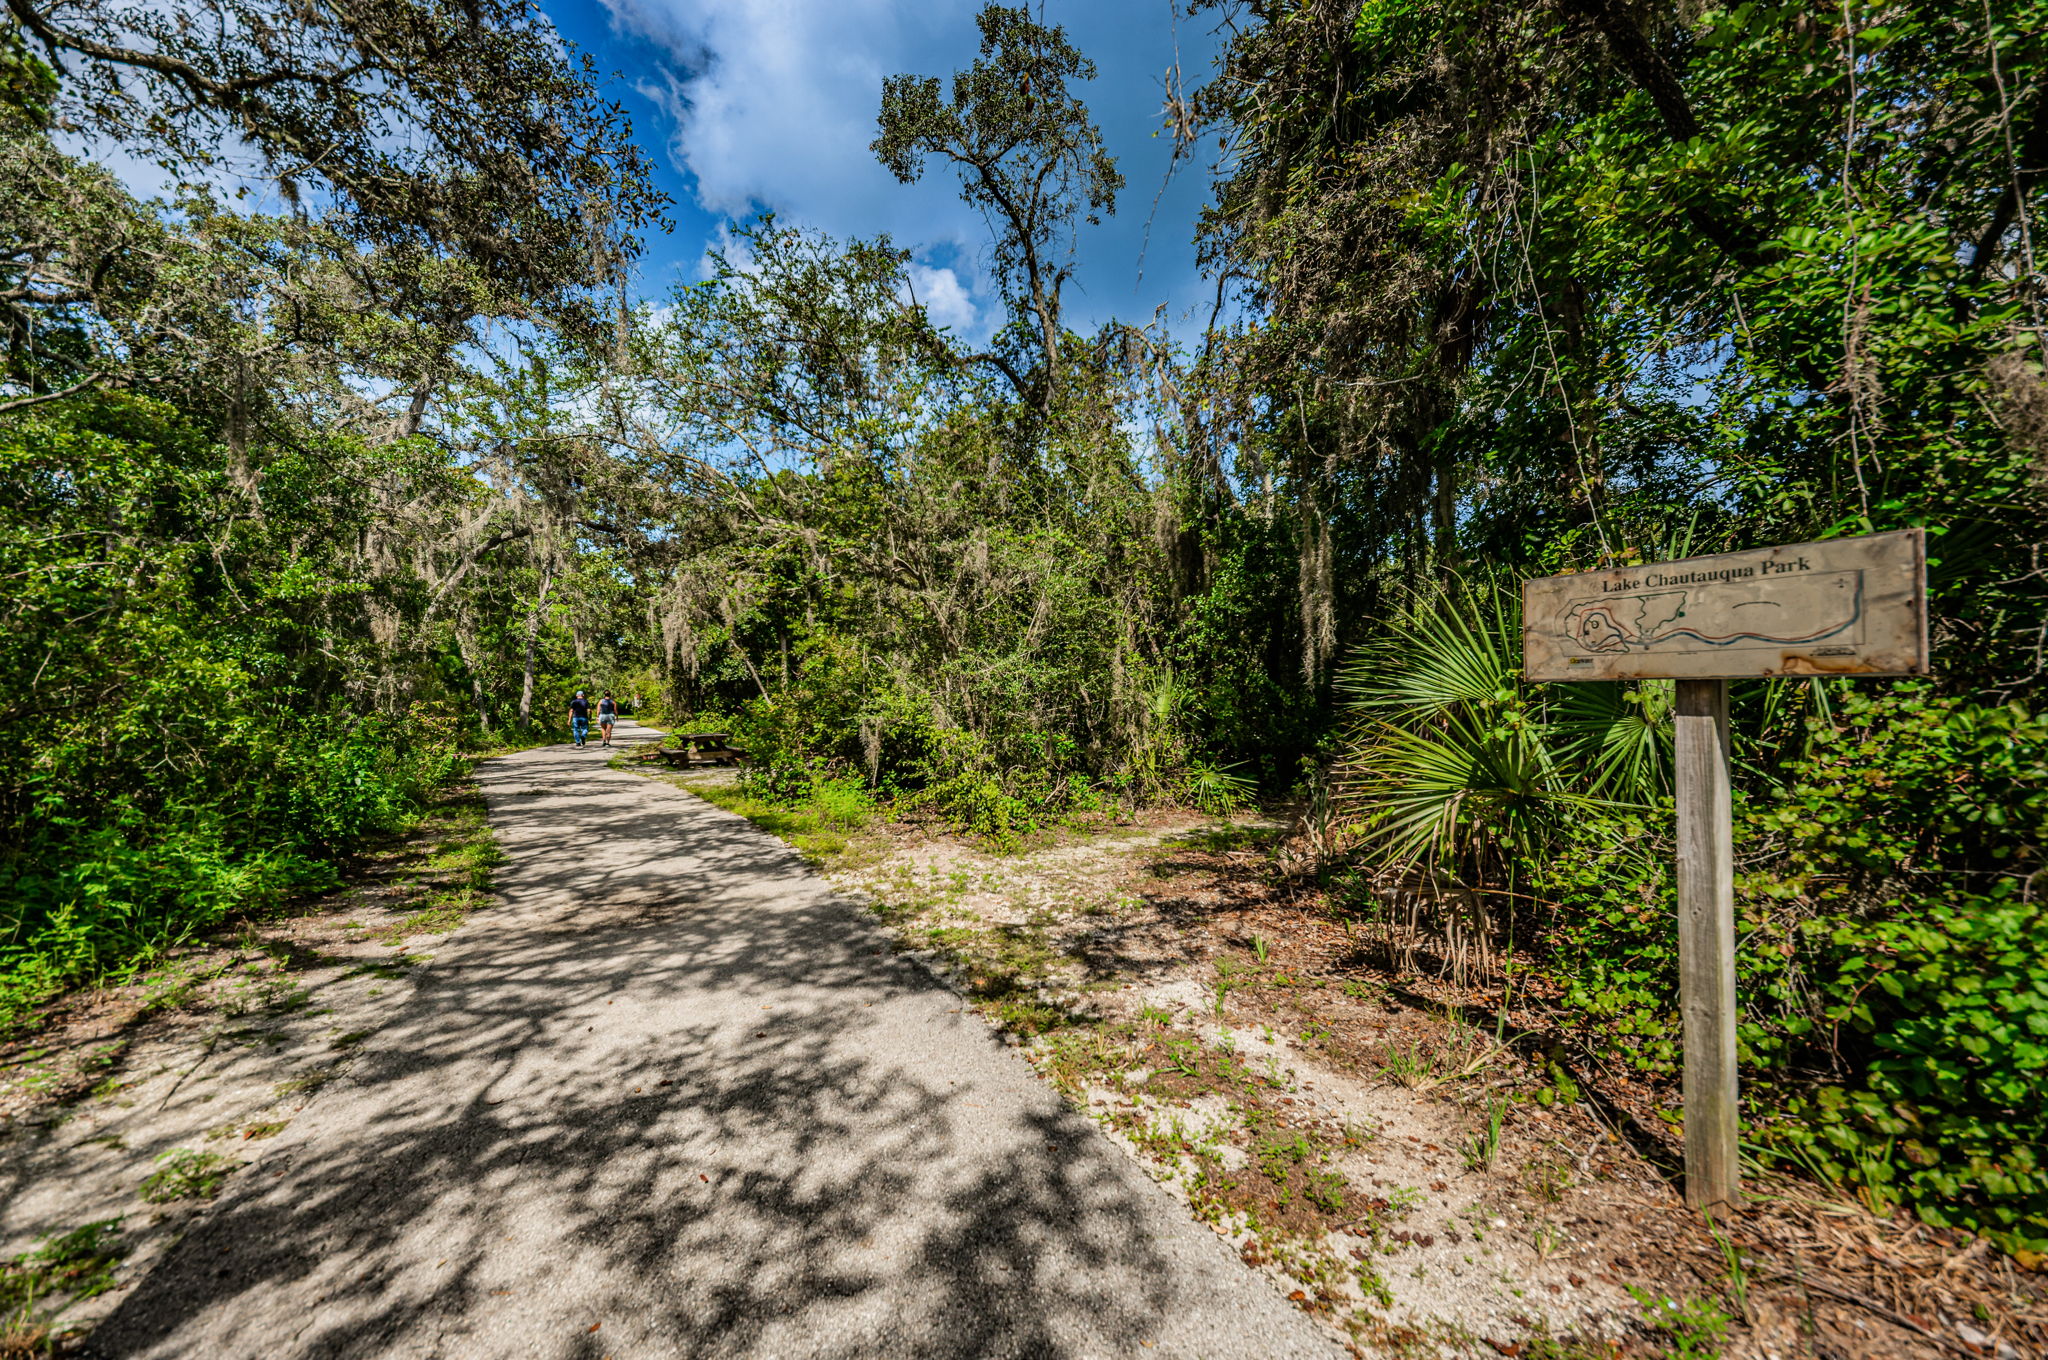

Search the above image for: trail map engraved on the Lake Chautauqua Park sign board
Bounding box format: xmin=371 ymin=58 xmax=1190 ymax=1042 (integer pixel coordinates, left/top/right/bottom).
xmin=1565 ymin=571 xmax=1864 ymax=651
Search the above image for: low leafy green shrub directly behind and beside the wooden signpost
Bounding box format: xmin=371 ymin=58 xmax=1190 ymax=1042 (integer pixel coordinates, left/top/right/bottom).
xmin=1532 ymin=684 xmax=2048 ymax=1249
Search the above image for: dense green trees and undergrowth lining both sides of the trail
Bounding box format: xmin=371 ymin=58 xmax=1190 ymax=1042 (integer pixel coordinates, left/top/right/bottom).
xmin=0 ymin=0 xmax=2048 ymax=1249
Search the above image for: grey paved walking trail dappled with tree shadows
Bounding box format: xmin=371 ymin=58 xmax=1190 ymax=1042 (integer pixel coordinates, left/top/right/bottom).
xmin=92 ymin=725 xmax=1341 ymax=1360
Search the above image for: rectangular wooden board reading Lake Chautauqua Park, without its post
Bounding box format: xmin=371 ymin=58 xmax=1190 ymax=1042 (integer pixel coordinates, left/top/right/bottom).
xmin=1522 ymin=528 xmax=1927 ymax=680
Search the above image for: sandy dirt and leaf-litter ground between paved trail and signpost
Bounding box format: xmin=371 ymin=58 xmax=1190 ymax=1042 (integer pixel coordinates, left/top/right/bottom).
xmin=802 ymin=813 xmax=2048 ymax=1360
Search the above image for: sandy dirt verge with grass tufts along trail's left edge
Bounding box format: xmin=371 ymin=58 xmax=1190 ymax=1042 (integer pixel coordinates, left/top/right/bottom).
xmin=0 ymin=789 xmax=496 ymax=1354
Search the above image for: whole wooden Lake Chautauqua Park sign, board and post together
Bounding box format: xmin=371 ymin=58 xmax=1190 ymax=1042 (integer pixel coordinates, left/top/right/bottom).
xmin=1522 ymin=528 xmax=1927 ymax=1208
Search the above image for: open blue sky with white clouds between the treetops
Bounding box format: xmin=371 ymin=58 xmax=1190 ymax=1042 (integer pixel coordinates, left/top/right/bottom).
xmin=543 ymin=0 xmax=1219 ymax=336
